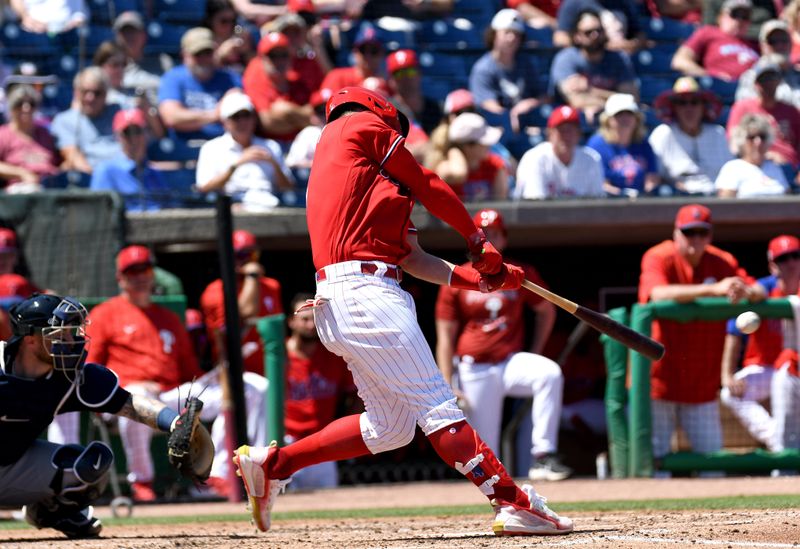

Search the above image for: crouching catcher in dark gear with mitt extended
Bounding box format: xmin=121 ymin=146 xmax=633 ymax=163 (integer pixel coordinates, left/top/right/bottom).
xmin=0 ymin=294 xmax=214 ymax=538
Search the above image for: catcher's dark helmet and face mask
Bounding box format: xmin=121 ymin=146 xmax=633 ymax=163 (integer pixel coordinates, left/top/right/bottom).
xmin=9 ymin=294 xmax=89 ymax=381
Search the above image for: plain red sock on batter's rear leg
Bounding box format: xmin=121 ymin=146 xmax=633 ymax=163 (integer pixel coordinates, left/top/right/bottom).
xmin=267 ymin=414 xmax=370 ymax=478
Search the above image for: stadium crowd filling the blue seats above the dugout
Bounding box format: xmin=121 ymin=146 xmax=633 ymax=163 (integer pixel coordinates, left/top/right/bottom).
xmin=0 ymin=0 xmax=800 ymax=206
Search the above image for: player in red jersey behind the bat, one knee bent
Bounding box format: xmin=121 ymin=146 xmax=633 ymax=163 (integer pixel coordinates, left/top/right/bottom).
xmin=436 ymin=209 xmax=572 ymax=480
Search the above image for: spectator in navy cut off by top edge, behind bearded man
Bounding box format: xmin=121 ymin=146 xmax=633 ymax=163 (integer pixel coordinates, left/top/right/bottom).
xmin=553 ymin=0 xmax=645 ymax=53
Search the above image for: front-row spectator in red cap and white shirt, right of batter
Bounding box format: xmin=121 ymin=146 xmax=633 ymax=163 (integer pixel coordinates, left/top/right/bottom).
xmin=514 ymin=105 xmax=605 ymax=200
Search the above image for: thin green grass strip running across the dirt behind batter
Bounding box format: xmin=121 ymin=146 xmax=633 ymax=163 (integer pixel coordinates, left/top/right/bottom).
xmin=0 ymin=495 xmax=800 ymax=530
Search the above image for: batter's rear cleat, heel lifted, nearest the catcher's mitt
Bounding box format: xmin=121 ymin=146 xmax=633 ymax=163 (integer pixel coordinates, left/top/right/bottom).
xmin=233 ymin=440 xmax=292 ymax=532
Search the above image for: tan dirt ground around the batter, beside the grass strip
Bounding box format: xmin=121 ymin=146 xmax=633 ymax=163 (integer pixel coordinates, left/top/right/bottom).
xmin=0 ymin=477 xmax=800 ymax=549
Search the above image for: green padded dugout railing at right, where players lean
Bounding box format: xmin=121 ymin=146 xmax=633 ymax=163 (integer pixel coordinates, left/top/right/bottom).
xmin=601 ymin=298 xmax=800 ymax=478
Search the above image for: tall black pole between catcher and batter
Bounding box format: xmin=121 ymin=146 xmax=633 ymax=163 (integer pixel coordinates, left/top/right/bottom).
xmin=217 ymin=193 xmax=247 ymax=446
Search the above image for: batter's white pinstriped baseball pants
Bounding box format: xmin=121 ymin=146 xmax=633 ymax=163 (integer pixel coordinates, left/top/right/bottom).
xmin=314 ymin=261 xmax=465 ymax=454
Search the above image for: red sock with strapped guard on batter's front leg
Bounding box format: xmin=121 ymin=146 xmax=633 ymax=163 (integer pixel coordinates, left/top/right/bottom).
xmin=428 ymin=421 xmax=531 ymax=508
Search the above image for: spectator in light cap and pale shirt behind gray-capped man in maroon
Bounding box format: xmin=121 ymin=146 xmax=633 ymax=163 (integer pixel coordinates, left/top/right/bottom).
xmin=736 ymin=19 xmax=800 ymax=107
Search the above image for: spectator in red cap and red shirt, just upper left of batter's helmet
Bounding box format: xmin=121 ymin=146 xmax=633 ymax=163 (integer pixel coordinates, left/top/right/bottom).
xmin=243 ymin=32 xmax=312 ymax=144
